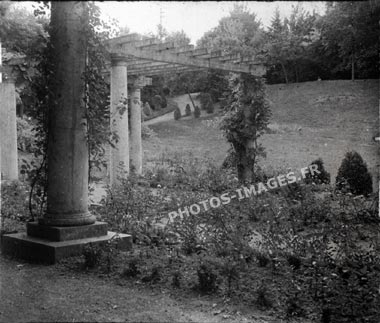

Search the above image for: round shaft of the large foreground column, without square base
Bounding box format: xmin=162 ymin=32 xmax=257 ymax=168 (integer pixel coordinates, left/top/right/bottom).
xmin=39 ymin=1 xmax=95 ymax=227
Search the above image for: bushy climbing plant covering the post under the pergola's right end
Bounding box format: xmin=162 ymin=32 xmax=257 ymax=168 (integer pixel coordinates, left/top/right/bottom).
xmin=221 ymin=74 xmax=271 ymax=182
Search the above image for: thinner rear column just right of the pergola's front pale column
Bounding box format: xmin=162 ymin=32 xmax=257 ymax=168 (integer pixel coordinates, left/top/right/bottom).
xmin=130 ymin=80 xmax=142 ymax=174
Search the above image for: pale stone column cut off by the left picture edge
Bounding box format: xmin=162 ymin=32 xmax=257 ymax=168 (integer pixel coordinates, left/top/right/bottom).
xmin=0 ymin=82 xmax=18 ymax=180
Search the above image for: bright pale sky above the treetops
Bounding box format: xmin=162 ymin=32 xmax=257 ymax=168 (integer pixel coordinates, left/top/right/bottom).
xmin=19 ymin=1 xmax=325 ymax=45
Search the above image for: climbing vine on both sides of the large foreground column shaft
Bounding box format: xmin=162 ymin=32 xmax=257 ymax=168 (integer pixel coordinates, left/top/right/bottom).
xmin=21 ymin=2 xmax=116 ymax=217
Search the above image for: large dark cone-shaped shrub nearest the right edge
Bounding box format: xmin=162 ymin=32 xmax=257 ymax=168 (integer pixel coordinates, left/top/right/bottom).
xmin=336 ymin=151 xmax=372 ymax=196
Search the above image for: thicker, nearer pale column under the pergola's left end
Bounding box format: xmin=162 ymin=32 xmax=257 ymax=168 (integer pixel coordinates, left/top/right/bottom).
xmin=110 ymin=57 xmax=129 ymax=186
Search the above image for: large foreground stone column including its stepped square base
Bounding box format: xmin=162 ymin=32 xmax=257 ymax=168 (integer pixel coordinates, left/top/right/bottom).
xmin=0 ymin=1 xmax=132 ymax=263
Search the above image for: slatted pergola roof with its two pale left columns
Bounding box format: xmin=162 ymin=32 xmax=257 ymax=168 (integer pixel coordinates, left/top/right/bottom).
xmin=105 ymin=34 xmax=265 ymax=185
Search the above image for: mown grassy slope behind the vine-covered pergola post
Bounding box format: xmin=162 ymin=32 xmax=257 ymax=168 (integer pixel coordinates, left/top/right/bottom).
xmin=144 ymin=80 xmax=379 ymax=187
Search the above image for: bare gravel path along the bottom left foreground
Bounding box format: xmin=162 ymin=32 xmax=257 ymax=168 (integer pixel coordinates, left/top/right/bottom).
xmin=0 ymin=257 xmax=280 ymax=323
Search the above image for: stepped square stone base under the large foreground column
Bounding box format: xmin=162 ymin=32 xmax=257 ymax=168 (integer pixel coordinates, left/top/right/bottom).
xmin=1 ymin=222 xmax=132 ymax=264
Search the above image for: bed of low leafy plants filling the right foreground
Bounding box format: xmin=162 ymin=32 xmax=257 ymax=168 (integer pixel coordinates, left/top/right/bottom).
xmin=85 ymin=156 xmax=380 ymax=323
